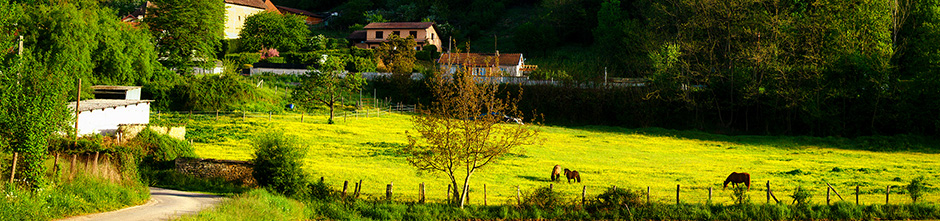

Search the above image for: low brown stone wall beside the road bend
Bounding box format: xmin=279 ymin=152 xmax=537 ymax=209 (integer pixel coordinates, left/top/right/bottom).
xmin=176 ymin=157 xmax=257 ymax=186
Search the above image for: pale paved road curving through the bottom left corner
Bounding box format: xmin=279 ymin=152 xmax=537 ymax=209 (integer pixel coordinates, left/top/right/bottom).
xmin=62 ymin=187 xmax=223 ymax=221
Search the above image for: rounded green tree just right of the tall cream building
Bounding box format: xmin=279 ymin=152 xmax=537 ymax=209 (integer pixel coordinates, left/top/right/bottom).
xmin=238 ymin=12 xmax=310 ymax=52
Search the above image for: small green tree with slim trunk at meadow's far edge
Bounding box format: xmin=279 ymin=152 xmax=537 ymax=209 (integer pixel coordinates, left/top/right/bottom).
xmin=292 ymin=56 xmax=366 ymax=124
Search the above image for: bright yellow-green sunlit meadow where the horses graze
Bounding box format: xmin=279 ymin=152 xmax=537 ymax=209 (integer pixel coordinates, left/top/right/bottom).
xmin=152 ymin=113 xmax=940 ymax=205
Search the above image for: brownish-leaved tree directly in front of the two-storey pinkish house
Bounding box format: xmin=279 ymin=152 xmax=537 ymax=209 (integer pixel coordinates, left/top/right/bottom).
xmin=375 ymin=35 xmax=418 ymax=76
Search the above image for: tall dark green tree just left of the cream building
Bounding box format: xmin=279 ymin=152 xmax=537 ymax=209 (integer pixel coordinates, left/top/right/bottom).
xmin=144 ymin=0 xmax=225 ymax=71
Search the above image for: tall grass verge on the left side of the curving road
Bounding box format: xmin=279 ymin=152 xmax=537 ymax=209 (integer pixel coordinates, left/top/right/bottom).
xmin=0 ymin=174 xmax=150 ymax=220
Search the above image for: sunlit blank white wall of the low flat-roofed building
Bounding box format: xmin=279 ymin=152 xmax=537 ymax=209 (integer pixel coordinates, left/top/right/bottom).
xmin=78 ymin=103 xmax=150 ymax=135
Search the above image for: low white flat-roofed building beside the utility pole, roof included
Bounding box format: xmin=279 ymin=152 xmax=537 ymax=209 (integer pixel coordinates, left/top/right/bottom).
xmin=68 ymin=86 xmax=153 ymax=135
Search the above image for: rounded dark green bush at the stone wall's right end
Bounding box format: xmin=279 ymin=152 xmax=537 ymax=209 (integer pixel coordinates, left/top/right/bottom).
xmin=251 ymin=132 xmax=307 ymax=197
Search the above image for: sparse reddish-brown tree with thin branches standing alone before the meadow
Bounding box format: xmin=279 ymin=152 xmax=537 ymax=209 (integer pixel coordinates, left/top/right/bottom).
xmin=403 ymin=60 xmax=538 ymax=208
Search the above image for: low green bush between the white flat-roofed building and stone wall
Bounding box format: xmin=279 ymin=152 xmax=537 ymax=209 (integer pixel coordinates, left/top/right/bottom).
xmin=131 ymin=128 xmax=196 ymax=162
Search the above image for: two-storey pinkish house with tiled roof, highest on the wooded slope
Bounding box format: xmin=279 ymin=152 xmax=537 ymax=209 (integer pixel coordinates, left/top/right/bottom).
xmin=347 ymin=22 xmax=441 ymax=52
